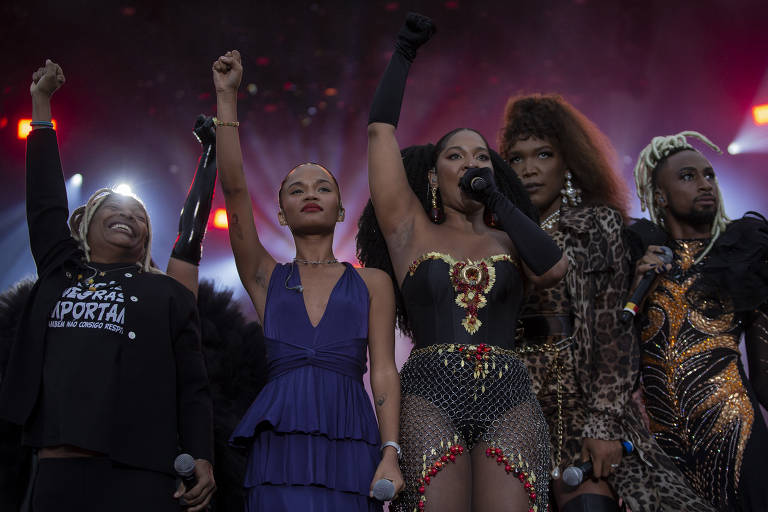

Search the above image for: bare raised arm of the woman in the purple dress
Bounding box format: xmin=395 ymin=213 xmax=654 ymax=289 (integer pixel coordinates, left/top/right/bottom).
xmin=213 ymin=50 xmax=275 ymax=319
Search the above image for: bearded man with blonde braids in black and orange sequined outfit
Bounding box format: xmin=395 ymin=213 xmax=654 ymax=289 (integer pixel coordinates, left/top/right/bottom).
xmin=630 ymin=132 xmax=768 ymax=512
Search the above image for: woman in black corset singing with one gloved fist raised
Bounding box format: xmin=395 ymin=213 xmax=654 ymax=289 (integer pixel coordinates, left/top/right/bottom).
xmin=357 ymin=14 xmax=567 ymax=512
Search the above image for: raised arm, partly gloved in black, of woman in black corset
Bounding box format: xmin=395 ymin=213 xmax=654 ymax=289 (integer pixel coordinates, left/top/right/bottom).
xmin=368 ymin=13 xmax=435 ymax=250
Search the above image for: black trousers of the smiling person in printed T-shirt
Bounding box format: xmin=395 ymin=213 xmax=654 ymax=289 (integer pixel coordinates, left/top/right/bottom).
xmin=32 ymin=457 xmax=181 ymax=512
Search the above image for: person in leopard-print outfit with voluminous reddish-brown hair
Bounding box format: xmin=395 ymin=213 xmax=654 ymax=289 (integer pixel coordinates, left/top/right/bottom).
xmin=499 ymin=95 xmax=712 ymax=512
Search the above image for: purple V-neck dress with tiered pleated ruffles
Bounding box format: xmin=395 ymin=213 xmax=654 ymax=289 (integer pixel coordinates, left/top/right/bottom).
xmin=230 ymin=263 xmax=382 ymax=512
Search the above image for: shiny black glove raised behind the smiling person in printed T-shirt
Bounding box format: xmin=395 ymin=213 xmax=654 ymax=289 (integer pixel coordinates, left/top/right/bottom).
xmin=171 ymin=114 xmax=216 ymax=265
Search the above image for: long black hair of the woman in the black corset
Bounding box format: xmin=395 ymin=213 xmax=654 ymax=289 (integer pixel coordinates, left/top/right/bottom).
xmin=357 ymin=128 xmax=538 ymax=337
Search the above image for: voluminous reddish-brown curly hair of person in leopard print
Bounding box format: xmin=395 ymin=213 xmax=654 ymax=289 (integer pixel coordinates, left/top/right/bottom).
xmin=499 ymin=94 xmax=629 ymax=220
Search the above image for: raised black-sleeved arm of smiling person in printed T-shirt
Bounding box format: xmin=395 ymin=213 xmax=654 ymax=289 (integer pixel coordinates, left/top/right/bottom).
xmin=26 ymin=60 xmax=76 ymax=274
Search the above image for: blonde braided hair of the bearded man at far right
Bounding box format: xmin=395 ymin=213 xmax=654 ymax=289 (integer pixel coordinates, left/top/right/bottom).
xmin=634 ymin=131 xmax=730 ymax=264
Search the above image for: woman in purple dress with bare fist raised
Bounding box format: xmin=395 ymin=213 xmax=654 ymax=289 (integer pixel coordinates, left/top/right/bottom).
xmin=213 ymin=51 xmax=403 ymax=511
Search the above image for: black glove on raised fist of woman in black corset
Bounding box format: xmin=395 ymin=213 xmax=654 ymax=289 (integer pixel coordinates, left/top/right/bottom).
xmin=368 ymin=12 xmax=437 ymax=127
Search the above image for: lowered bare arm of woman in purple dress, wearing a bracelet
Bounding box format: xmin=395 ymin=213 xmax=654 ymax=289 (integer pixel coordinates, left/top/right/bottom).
xmin=359 ymin=268 xmax=405 ymax=500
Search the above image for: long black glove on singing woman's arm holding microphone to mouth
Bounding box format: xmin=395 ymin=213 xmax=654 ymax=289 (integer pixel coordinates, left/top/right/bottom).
xmin=459 ymin=167 xmax=563 ymax=276
